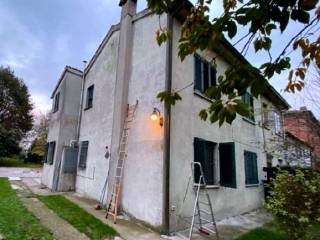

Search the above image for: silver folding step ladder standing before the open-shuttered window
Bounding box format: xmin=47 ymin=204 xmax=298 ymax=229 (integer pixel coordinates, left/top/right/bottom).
xmin=189 ymin=162 xmax=219 ymax=240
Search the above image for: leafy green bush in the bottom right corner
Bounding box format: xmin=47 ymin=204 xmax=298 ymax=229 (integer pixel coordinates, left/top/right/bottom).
xmin=266 ymin=169 xmax=320 ymax=240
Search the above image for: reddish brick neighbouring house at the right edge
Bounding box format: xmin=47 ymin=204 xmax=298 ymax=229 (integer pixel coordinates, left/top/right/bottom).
xmin=284 ymin=107 xmax=320 ymax=170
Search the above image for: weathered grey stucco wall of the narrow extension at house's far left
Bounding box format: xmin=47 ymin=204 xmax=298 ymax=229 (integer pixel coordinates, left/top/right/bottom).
xmin=41 ymin=70 xmax=82 ymax=191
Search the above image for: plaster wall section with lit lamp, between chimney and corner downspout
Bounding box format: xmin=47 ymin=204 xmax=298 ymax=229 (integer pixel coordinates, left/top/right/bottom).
xmin=122 ymin=15 xmax=166 ymax=227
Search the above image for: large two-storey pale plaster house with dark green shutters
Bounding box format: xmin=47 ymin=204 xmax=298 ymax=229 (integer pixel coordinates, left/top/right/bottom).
xmin=42 ymin=0 xmax=289 ymax=233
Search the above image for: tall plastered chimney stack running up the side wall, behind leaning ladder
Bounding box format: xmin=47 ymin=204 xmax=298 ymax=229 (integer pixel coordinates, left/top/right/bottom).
xmin=107 ymin=0 xmax=137 ymax=199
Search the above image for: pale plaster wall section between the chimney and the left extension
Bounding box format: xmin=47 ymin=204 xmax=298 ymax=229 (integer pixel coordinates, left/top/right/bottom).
xmin=76 ymin=31 xmax=119 ymax=199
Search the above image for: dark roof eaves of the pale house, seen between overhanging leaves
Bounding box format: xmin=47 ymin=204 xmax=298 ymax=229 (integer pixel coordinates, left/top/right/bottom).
xmin=171 ymin=0 xmax=290 ymax=109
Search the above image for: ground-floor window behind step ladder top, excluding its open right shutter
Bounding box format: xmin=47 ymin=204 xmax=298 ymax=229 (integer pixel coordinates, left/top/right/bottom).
xmin=194 ymin=138 xmax=216 ymax=185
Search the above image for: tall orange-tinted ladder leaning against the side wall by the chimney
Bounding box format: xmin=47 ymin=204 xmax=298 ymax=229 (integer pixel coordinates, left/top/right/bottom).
xmin=106 ymin=101 xmax=138 ymax=223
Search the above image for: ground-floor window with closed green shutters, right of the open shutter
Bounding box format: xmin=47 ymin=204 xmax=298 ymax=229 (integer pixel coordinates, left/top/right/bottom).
xmin=244 ymin=151 xmax=259 ymax=185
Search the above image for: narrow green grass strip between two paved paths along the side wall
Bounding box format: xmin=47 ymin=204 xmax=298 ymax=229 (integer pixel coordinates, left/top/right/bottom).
xmin=39 ymin=195 xmax=117 ymax=240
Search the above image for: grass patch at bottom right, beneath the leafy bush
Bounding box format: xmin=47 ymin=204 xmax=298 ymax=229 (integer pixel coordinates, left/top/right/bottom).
xmin=237 ymin=222 xmax=320 ymax=240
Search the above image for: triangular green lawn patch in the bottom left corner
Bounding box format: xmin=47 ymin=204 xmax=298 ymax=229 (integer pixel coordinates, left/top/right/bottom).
xmin=0 ymin=178 xmax=53 ymax=240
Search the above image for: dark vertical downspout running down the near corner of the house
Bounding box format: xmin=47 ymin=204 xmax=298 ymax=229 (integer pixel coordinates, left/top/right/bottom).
xmin=162 ymin=14 xmax=173 ymax=235
